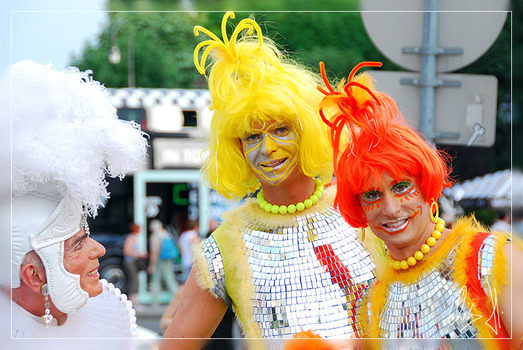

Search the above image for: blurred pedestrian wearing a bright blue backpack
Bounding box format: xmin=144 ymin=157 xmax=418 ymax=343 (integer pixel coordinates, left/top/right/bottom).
xmin=147 ymin=219 xmax=179 ymax=305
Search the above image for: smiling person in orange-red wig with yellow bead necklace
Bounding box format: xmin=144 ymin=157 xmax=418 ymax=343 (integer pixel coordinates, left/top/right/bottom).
xmin=320 ymin=62 xmax=510 ymax=348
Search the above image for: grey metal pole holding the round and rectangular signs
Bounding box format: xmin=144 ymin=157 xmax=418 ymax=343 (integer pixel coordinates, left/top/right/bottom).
xmin=420 ymin=0 xmax=438 ymax=141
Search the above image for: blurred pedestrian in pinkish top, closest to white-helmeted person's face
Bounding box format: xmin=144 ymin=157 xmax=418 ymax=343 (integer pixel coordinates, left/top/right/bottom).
xmin=123 ymin=222 xmax=148 ymax=306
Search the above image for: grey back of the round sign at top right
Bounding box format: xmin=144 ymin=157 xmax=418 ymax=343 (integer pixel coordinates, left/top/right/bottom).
xmin=361 ymin=0 xmax=509 ymax=72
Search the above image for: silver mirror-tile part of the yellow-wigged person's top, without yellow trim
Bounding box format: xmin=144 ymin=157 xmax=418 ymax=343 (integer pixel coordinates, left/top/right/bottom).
xmin=203 ymin=205 xmax=375 ymax=338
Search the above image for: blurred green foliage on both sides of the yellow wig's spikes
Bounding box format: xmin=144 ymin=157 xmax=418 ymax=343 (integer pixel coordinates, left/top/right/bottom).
xmin=72 ymin=12 xmax=395 ymax=88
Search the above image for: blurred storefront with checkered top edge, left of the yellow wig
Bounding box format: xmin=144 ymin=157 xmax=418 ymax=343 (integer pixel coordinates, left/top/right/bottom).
xmin=92 ymin=88 xmax=235 ymax=303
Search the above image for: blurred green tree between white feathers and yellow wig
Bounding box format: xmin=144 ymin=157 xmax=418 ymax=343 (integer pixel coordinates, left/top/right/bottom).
xmin=72 ymin=12 xmax=203 ymax=88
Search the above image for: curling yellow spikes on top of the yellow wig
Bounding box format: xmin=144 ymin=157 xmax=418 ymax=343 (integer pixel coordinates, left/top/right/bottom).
xmin=194 ymin=11 xmax=263 ymax=74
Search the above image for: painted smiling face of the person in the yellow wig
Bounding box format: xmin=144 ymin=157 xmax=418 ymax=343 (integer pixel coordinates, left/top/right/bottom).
xmin=242 ymin=122 xmax=299 ymax=185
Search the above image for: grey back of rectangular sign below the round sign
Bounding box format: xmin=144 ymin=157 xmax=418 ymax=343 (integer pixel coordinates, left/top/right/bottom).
xmin=366 ymin=70 xmax=498 ymax=147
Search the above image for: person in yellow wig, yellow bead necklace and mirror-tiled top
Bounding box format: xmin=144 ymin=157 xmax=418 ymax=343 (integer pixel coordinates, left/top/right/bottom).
xmin=164 ymin=12 xmax=374 ymax=346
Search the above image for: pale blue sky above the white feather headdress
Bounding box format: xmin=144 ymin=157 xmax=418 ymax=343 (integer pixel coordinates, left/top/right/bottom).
xmin=0 ymin=0 xmax=107 ymax=74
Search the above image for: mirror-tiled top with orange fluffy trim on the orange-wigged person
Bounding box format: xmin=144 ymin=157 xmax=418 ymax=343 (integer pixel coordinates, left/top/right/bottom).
xmin=366 ymin=217 xmax=506 ymax=339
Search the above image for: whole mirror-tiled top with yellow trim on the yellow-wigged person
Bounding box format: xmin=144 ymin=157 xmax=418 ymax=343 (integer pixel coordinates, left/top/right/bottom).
xmin=196 ymin=188 xmax=374 ymax=338
